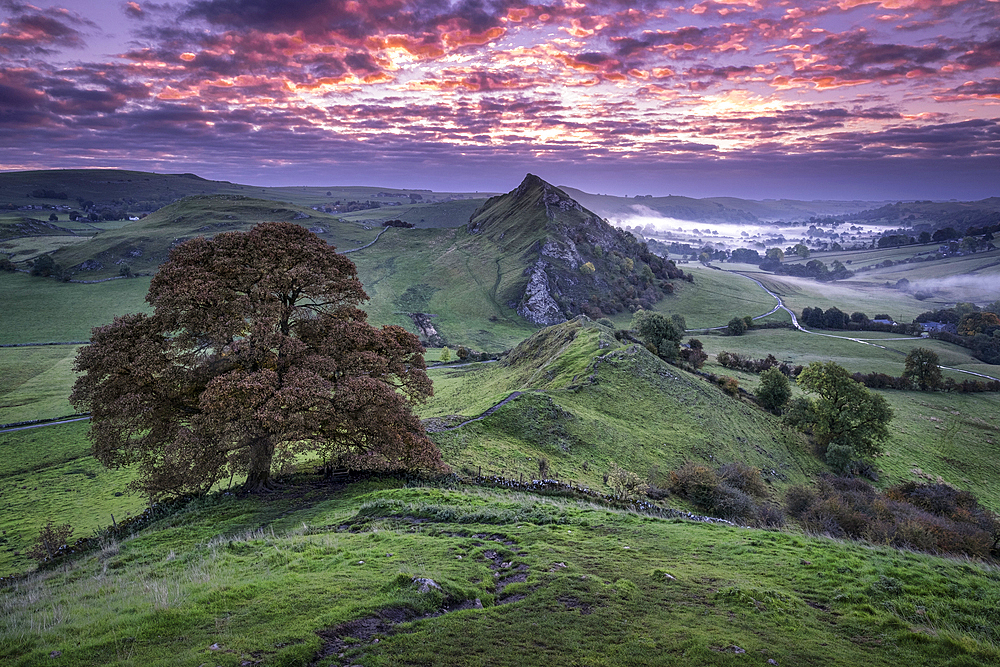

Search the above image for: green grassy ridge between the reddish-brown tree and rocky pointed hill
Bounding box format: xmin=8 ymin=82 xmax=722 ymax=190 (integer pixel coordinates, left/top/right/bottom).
xmin=422 ymin=318 xmax=821 ymax=488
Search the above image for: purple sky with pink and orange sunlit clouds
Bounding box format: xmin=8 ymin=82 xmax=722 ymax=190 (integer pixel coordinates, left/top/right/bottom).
xmin=0 ymin=0 xmax=1000 ymax=200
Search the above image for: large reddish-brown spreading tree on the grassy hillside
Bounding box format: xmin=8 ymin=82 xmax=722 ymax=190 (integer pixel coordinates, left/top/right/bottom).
xmin=70 ymin=223 xmax=442 ymax=498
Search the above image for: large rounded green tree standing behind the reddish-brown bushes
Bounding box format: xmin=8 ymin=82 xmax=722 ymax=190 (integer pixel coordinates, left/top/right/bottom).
xmin=797 ymin=361 xmax=892 ymax=468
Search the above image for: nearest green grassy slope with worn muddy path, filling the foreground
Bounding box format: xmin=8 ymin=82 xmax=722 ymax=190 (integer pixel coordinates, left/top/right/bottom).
xmin=0 ymin=484 xmax=1000 ymax=667
